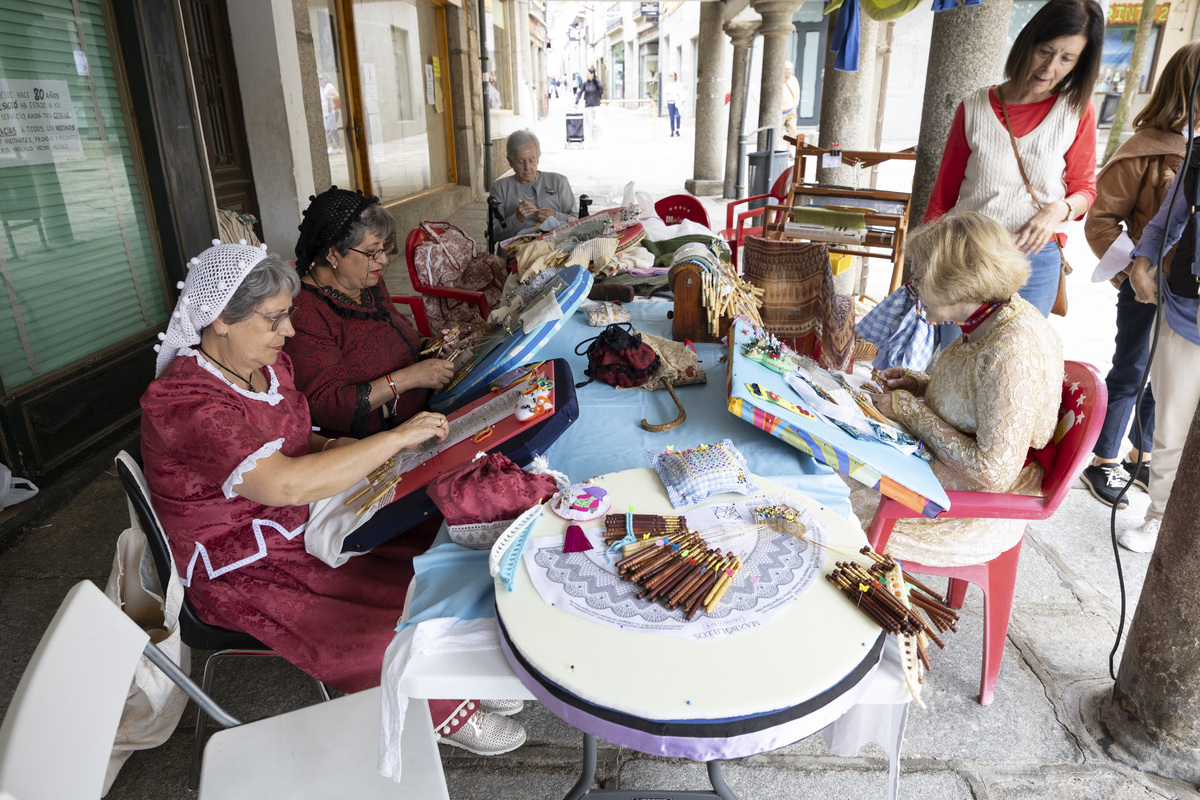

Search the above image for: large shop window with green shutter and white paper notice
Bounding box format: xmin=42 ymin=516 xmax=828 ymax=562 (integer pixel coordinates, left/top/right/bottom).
xmin=0 ymin=0 xmax=168 ymax=391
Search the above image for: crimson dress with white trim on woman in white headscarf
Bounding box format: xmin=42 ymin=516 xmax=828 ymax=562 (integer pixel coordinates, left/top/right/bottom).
xmin=142 ymin=348 xmax=434 ymax=692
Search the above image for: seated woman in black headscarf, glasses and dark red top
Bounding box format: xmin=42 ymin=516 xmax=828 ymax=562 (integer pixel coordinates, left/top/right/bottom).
xmin=284 ymin=186 xmax=454 ymax=438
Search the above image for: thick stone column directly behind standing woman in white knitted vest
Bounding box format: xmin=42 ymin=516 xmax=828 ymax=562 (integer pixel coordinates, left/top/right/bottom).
xmin=908 ymin=0 xmax=1013 ymax=225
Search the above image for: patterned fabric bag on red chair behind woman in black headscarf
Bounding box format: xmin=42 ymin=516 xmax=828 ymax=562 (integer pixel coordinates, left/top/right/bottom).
xmin=413 ymin=222 xmax=508 ymax=330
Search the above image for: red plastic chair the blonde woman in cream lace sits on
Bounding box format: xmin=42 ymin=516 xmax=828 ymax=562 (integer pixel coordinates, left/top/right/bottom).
xmin=866 ymin=361 xmax=1109 ymax=705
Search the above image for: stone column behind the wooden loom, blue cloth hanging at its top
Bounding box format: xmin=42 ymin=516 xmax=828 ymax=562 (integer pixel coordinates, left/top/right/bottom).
xmin=817 ymin=8 xmax=878 ymax=188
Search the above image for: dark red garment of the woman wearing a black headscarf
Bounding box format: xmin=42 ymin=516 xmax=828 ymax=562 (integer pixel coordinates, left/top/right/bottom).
xmin=283 ymin=278 xmax=430 ymax=439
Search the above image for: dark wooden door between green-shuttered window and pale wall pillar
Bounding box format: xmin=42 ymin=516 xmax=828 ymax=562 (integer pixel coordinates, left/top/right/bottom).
xmin=181 ymin=0 xmax=263 ymax=239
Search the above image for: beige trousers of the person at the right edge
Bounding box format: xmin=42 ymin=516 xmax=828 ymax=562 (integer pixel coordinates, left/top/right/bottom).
xmin=1146 ymin=324 xmax=1200 ymax=519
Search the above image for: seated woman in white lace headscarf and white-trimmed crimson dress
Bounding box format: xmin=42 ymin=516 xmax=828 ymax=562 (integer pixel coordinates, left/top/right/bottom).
xmin=142 ymin=243 xmax=524 ymax=754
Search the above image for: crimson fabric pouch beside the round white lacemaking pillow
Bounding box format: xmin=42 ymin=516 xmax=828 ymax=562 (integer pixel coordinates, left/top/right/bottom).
xmin=426 ymin=452 xmax=558 ymax=525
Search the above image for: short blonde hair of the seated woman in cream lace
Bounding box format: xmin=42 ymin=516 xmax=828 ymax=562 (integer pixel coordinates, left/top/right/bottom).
xmin=907 ymin=211 xmax=1030 ymax=306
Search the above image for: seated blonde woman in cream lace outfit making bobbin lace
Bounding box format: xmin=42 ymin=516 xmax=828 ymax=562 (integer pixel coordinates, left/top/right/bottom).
xmin=847 ymin=212 xmax=1063 ymax=566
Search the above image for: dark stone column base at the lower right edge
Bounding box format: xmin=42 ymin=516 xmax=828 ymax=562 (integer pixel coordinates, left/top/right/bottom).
xmin=1100 ymin=414 xmax=1200 ymax=783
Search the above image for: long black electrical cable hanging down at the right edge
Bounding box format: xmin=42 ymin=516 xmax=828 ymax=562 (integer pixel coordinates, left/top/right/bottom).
xmin=1109 ymin=59 xmax=1200 ymax=681
